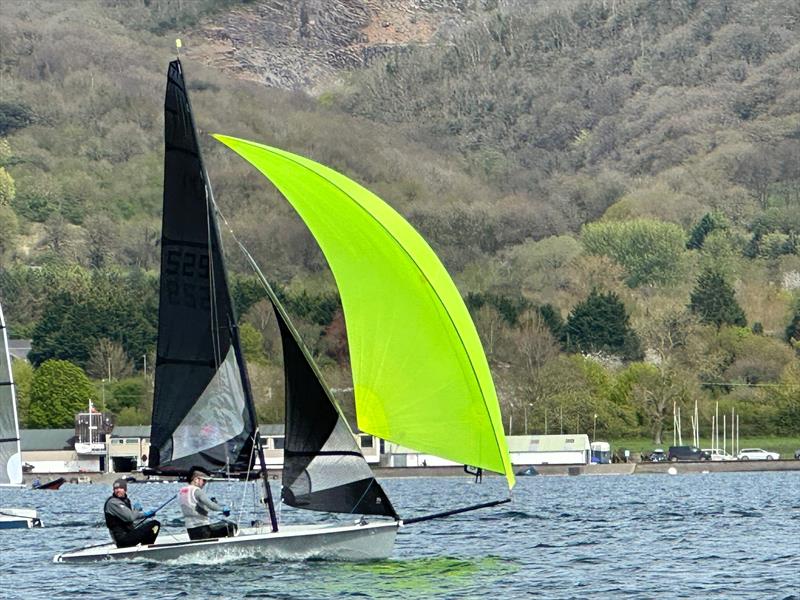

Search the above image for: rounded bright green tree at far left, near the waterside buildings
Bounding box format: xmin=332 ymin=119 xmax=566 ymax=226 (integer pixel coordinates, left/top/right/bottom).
xmin=28 ymin=360 xmax=96 ymax=429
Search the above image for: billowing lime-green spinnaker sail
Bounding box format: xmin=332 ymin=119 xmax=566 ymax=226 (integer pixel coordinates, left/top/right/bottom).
xmin=214 ymin=135 xmax=514 ymax=487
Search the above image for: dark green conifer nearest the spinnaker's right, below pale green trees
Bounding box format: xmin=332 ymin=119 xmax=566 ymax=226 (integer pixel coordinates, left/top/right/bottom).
xmin=563 ymin=290 xmax=643 ymax=360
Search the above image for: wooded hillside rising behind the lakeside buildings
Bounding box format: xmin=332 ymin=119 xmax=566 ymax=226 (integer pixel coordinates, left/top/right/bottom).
xmin=0 ymin=0 xmax=800 ymax=437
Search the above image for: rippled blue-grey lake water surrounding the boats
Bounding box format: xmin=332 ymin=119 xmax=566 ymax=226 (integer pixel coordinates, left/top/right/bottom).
xmin=0 ymin=471 xmax=800 ymax=600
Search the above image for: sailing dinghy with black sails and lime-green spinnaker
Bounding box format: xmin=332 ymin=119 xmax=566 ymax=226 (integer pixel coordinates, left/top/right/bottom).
xmin=54 ymin=60 xmax=514 ymax=562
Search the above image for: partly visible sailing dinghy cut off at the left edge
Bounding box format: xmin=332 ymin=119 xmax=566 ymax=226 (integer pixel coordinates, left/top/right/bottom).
xmin=0 ymin=306 xmax=42 ymax=529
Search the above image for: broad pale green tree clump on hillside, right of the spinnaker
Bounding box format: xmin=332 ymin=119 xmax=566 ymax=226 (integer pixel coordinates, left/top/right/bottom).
xmin=581 ymin=219 xmax=684 ymax=287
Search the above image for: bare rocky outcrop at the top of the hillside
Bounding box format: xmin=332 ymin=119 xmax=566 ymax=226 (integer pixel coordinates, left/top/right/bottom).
xmin=187 ymin=0 xmax=480 ymax=93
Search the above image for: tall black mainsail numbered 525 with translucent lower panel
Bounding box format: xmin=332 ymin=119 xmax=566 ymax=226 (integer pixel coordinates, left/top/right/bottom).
xmin=149 ymin=60 xmax=256 ymax=471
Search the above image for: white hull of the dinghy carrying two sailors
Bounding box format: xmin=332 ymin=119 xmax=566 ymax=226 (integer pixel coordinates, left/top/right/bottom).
xmin=53 ymin=521 xmax=400 ymax=562
